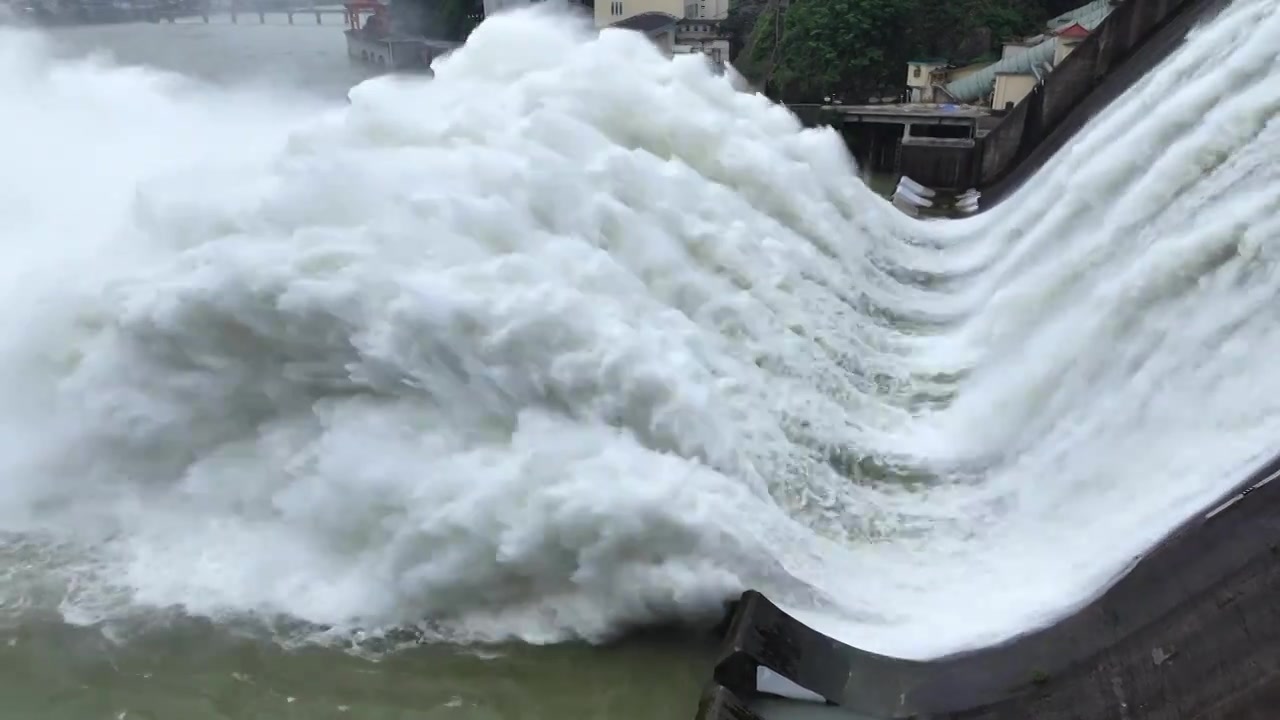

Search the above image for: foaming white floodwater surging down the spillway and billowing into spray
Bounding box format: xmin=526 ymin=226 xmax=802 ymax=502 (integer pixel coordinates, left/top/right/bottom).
xmin=0 ymin=0 xmax=1280 ymax=657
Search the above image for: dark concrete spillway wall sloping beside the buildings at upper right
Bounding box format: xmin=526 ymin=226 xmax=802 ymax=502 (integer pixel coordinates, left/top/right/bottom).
xmin=974 ymin=0 xmax=1229 ymax=208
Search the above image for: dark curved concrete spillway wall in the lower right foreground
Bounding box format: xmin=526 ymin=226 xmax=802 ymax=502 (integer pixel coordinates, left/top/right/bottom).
xmin=699 ymin=456 xmax=1280 ymax=720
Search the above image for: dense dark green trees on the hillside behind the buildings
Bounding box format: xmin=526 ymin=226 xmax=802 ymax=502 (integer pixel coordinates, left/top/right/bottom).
xmin=731 ymin=0 xmax=1064 ymax=101
